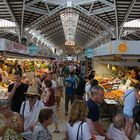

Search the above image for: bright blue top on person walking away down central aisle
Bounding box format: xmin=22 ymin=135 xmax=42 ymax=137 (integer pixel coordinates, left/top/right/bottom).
xmin=64 ymin=76 xmax=76 ymax=95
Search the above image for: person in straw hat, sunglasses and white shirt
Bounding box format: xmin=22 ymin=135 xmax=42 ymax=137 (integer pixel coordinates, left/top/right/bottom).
xmin=20 ymin=87 xmax=44 ymax=140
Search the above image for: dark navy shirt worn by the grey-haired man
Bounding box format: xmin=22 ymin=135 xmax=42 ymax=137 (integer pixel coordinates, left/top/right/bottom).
xmin=87 ymin=99 xmax=100 ymax=122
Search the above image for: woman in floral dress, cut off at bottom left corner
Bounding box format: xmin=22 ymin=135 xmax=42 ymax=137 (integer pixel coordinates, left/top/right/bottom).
xmin=0 ymin=98 xmax=24 ymax=140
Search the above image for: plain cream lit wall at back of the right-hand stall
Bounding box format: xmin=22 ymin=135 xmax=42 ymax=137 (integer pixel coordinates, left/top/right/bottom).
xmin=94 ymin=61 xmax=111 ymax=77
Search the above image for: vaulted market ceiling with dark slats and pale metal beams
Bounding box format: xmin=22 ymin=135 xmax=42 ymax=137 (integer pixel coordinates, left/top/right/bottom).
xmin=0 ymin=0 xmax=140 ymax=54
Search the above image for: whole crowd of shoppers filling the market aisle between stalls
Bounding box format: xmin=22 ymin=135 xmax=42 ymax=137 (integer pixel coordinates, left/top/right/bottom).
xmin=0 ymin=61 xmax=140 ymax=140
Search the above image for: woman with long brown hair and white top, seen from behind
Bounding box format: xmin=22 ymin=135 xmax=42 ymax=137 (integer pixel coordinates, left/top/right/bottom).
xmin=64 ymin=100 xmax=91 ymax=140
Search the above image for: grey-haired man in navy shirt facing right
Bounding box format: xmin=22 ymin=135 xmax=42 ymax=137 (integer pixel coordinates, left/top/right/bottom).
xmin=87 ymin=86 xmax=109 ymax=140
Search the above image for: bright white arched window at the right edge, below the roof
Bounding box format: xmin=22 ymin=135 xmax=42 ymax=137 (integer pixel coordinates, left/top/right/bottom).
xmin=123 ymin=19 xmax=140 ymax=28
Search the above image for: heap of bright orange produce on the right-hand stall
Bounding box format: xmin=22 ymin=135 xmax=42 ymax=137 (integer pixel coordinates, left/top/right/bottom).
xmin=104 ymin=90 xmax=124 ymax=101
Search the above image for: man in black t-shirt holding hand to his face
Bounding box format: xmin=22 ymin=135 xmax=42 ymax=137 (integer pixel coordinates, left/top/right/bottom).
xmin=8 ymin=71 xmax=28 ymax=113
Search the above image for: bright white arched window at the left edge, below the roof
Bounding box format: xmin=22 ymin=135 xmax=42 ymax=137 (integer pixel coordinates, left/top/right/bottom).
xmin=0 ymin=19 xmax=16 ymax=27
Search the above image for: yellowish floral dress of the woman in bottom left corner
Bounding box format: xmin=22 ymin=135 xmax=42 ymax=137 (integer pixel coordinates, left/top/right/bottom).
xmin=0 ymin=113 xmax=23 ymax=140
